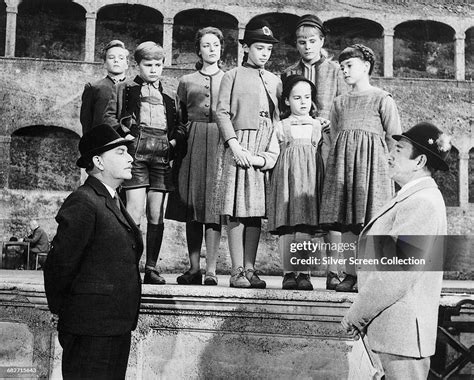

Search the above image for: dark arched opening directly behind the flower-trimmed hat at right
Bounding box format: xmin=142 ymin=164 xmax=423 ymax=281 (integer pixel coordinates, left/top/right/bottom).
xmin=433 ymin=146 xmax=459 ymax=207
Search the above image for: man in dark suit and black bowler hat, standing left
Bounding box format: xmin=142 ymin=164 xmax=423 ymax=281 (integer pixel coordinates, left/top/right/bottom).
xmin=44 ymin=125 xmax=143 ymax=379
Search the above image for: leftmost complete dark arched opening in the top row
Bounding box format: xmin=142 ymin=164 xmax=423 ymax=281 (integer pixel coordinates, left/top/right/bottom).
xmin=15 ymin=0 xmax=86 ymax=60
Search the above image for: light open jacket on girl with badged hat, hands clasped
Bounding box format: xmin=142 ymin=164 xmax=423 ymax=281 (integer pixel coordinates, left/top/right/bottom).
xmin=216 ymin=66 xmax=281 ymax=142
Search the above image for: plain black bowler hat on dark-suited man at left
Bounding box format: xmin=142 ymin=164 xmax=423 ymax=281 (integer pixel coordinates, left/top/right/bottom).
xmin=76 ymin=124 xmax=133 ymax=168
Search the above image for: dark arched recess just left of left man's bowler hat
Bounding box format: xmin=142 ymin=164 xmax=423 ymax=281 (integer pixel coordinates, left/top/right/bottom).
xmin=8 ymin=125 xmax=81 ymax=191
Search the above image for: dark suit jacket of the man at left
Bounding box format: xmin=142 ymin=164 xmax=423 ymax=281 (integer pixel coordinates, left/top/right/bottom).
xmin=44 ymin=176 xmax=143 ymax=336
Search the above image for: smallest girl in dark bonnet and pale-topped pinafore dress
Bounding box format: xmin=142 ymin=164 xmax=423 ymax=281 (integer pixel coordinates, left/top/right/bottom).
xmin=268 ymin=75 xmax=329 ymax=290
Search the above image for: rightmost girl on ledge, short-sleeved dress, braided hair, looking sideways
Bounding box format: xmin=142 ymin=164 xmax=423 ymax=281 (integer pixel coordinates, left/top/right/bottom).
xmin=320 ymin=44 xmax=402 ymax=292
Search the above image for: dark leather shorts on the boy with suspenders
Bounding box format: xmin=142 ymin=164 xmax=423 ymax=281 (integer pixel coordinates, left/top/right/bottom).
xmin=122 ymin=127 xmax=174 ymax=192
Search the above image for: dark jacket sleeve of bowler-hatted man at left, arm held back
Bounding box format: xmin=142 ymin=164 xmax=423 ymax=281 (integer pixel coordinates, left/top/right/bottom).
xmin=44 ymin=192 xmax=96 ymax=314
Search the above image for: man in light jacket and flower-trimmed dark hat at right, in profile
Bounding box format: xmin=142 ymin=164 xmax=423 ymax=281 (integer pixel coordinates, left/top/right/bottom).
xmin=342 ymin=123 xmax=451 ymax=380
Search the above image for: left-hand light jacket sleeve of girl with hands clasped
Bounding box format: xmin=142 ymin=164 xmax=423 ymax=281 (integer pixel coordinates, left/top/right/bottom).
xmin=216 ymin=70 xmax=237 ymax=142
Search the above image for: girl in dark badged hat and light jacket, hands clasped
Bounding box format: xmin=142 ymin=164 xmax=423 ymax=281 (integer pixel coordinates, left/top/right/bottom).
xmin=214 ymin=21 xmax=281 ymax=288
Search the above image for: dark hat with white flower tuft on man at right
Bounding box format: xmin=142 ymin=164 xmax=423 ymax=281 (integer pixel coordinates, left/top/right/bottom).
xmin=392 ymin=122 xmax=451 ymax=171
